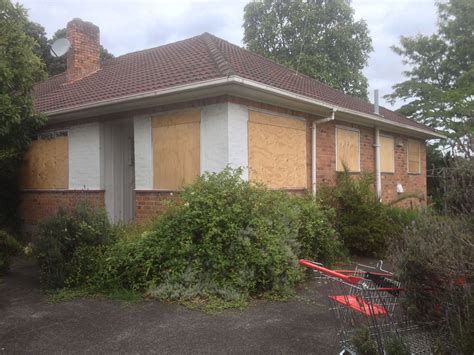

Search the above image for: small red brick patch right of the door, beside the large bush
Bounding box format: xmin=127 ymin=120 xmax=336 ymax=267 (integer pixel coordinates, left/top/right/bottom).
xmin=135 ymin=190 xmax=179 ymax=223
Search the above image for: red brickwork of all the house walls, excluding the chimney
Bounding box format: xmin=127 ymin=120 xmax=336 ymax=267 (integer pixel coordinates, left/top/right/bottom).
xmin=20 ymin=95 xmax=426 ymax=224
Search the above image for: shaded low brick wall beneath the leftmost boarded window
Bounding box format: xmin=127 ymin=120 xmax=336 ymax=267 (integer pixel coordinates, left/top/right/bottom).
xmin=20 ymin=190 xmax=105 ymax=225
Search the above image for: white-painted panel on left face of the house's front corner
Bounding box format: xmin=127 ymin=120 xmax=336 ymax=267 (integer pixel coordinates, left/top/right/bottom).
xmin=200 ymin=103 xmax=228 ymax=174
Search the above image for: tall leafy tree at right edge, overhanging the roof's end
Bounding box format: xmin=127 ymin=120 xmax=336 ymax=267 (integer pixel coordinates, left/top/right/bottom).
xmin=386 ymin=0 xmax=474 ymax=159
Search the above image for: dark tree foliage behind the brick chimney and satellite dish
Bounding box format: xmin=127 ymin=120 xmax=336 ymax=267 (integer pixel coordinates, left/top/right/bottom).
xmin=27 ymin=25 xmax=114 ymax=76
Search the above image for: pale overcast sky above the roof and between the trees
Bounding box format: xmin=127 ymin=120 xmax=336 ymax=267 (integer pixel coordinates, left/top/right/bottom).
xmin=19 ymin=0 xmax=436 ymax=107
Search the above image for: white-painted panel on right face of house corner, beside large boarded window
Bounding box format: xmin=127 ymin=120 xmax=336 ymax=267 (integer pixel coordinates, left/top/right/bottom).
xmin=228 ymin=103 xmax=249 ymax=180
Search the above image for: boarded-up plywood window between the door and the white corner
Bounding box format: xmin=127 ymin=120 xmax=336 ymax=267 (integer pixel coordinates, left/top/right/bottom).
xmin=152 ymin=111 xmax=201 ymax=190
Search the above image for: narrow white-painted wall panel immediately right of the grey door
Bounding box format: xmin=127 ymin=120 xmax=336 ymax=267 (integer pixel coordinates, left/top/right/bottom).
xmin=133 ymin=116 xmax=153 ymax=190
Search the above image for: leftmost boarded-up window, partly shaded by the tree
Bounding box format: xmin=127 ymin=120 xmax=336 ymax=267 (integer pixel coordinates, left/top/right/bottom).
xmin=20 ymin=133 xmax=69 ymax=189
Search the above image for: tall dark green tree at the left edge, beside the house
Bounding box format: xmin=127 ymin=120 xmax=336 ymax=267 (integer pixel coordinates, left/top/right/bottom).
xmin=0 ymin=0 xmax=46 ymax=228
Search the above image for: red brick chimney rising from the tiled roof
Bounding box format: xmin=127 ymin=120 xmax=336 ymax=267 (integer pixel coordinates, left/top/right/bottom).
xmin=66 ymin=18 xmax=100 ymax=82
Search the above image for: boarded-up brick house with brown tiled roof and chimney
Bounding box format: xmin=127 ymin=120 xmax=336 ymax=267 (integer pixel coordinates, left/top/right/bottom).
xmin=21 ymin=19 xmax=442 ymax=229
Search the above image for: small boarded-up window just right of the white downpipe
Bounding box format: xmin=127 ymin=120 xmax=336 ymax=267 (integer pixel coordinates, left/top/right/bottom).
xmin=336 ymin=127 xmax=360 ymax=172
